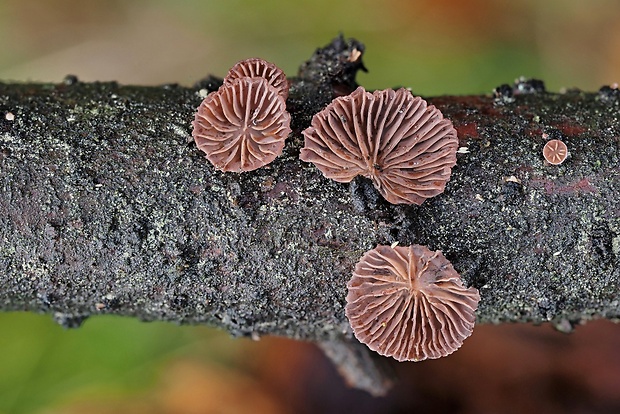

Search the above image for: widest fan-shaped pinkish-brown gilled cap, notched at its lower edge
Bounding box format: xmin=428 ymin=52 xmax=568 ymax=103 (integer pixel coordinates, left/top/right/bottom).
xmin=300 ymin=87 xmax=458 ymax=204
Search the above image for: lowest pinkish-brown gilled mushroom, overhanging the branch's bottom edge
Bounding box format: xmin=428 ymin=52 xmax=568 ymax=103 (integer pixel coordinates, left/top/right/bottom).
xmin=345 ymin=245 xmax=480 ymax=361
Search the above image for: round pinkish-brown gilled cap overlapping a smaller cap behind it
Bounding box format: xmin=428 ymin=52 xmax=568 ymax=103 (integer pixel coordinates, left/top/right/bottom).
xmin=192 ymin=78 xmax=291 ymax=172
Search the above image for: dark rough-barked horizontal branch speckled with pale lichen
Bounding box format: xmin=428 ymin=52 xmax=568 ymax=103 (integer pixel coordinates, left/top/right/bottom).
xmin=0 ymin=38 xmax=620 ymax=394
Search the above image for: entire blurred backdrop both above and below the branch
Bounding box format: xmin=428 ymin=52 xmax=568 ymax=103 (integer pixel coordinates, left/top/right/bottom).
xmin=0 ymin=0 xmax=620 ymax=414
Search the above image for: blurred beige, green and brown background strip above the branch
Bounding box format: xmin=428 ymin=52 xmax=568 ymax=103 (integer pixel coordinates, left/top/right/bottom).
xmin=0 ymin=0 xmax=620 ymax=95
